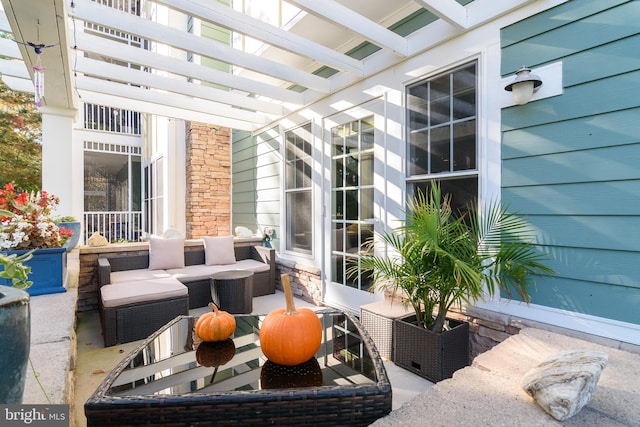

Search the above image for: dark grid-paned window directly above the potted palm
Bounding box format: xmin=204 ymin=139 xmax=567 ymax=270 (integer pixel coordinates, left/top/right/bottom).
xmin=407 ymin=62 xmax=478 ymax=211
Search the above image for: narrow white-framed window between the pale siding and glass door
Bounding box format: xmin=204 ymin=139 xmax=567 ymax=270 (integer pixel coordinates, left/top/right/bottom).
xmin=284 ymin=123 xmax=313 ymax=254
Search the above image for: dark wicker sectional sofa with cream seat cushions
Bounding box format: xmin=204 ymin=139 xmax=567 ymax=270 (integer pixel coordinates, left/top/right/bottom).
xmin=98 ymin=246 xmax=276 ymax=347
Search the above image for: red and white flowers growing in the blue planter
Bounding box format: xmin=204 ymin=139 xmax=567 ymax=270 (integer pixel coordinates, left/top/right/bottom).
xmin=0 ymin=183 xmax=73 ymax=250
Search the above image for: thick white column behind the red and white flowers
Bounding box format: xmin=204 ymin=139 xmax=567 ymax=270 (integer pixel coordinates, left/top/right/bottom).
xmin=40 ymin=107 xmax=84 ymax=221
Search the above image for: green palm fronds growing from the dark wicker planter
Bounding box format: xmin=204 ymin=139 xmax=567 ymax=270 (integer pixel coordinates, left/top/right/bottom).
xmin=348 ymin=183 xmax=553 ymax=332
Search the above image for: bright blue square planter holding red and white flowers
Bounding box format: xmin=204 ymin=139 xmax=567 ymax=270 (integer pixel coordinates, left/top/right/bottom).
xmin=0 ymin=248 xmax=67 ymax=296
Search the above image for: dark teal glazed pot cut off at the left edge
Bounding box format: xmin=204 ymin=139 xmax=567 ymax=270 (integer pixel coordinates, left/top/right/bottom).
xmin=0 ymin=286 xmax=31 ymax=404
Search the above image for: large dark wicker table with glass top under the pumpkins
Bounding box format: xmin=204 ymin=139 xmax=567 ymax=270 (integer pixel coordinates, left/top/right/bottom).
xmin=84 ymin=310 xmax=391 ymax=426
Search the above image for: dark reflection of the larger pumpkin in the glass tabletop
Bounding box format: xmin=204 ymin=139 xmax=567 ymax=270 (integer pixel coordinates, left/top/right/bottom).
xmin=260 ymin=357 xmax=323 ymax=390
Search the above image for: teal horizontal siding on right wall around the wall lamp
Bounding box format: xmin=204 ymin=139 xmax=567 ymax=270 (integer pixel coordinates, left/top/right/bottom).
xmin=501 ymin=0 xmax=640 ymax=324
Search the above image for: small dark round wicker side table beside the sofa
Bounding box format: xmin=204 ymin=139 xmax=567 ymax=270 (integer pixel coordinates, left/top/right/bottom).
xmin=210 ymin=270 xmax=253 ymax=314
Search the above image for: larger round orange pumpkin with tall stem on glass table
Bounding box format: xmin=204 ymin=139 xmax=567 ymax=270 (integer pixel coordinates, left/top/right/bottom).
xmin=260 ymin=274 xmax=322 ymax=366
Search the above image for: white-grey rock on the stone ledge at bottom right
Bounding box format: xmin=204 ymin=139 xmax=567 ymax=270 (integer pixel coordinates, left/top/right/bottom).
xmin=522 ymin=350 xmax=609 ymax=421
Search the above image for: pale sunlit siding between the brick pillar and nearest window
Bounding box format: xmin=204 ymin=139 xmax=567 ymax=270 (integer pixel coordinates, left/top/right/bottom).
xmin=231 ymin=129 xmax=282 ymax=249
